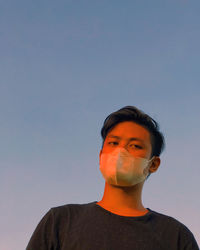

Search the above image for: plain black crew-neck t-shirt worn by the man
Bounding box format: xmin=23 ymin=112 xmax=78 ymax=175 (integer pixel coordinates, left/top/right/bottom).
xmin=26 ymin=201 xmax=199 ymax=250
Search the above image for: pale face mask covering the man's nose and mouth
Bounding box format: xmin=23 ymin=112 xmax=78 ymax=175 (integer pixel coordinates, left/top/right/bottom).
xmin=100 ymin=148 xmax=153 ymax=186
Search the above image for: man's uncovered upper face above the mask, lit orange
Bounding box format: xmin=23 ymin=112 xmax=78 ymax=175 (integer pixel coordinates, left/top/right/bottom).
xmin=100 ymin=121 xmax=152 ymax=159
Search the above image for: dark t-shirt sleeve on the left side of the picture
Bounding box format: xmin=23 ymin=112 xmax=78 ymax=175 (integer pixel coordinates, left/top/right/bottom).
xmin=26 ymin=209 xmax=54 ymax=250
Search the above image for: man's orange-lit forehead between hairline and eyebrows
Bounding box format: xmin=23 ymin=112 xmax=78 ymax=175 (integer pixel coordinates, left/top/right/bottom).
xmin=107 ymin=121 xmax=150 ymax=143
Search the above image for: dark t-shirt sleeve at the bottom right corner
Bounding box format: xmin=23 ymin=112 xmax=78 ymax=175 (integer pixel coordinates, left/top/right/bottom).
xmin=179 ymin=225 xmax=199 ymax=250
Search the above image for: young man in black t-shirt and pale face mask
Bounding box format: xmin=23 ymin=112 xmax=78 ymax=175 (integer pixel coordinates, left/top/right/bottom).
xmin=27 ymin=106 xmax=199 ymax=250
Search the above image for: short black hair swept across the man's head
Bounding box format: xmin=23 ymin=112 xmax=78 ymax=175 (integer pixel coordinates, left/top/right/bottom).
xmin=101 ymin=106 xmax=165 ymax=158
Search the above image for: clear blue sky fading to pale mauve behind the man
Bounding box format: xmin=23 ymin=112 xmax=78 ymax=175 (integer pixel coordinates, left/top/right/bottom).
xmin=0 ymin=0 xmax=200 ymax=250
